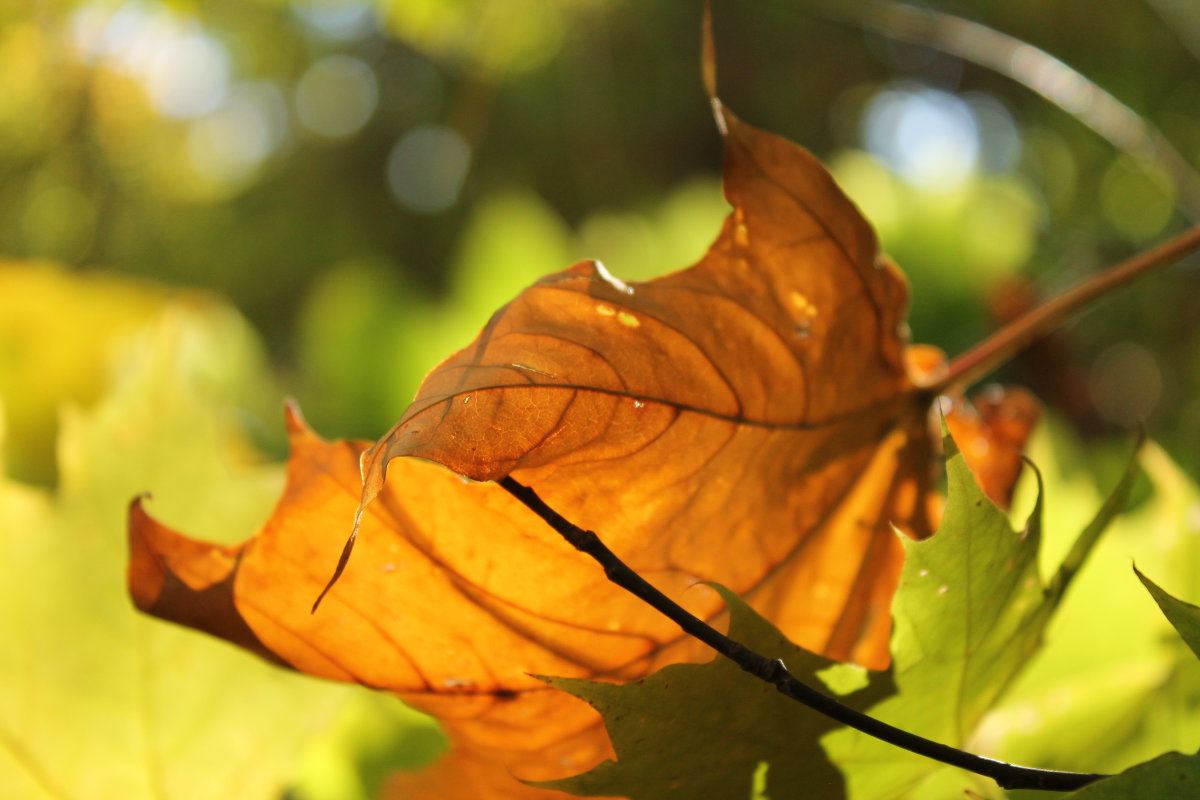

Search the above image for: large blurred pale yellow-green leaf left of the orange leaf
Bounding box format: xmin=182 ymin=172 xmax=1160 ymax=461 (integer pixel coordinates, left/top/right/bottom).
xmin=0 ymin=303 xmax=350 ymax=800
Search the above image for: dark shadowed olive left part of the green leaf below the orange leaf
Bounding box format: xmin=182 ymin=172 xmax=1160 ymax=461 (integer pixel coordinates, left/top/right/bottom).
xmin=539 ymin=587 xmax=892 ymax=800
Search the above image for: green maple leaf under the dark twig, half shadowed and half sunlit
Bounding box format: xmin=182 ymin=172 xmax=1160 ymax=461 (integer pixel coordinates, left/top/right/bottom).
xmin=520 ymin=441 xmax=1135 ymax=800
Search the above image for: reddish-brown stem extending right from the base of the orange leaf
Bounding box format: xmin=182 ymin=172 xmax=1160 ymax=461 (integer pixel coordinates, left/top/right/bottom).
xmin=929 ymin=227 xmax=1200 ymax=393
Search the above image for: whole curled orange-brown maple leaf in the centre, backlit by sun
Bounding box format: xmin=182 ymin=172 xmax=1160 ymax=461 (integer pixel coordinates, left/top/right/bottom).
xmin=130 ymin=95 xmax=1027 ymax=798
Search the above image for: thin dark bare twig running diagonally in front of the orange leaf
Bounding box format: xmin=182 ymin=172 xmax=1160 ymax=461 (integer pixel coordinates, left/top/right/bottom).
xmin=499 ymin=477 xmax=1108 ymax=792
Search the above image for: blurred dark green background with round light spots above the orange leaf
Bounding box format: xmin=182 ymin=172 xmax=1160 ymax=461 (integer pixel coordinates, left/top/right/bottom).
xmin=7 ymin=0 xmax=1200 ymax=796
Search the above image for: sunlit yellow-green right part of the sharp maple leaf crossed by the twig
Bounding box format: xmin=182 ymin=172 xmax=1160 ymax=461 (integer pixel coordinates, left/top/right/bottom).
xmin=826 ymin=438 xmax=1135 ymax=800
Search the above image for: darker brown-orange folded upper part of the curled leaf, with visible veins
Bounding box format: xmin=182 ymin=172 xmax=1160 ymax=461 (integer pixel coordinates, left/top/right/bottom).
xmin=355 ymin=104 xmax=931 ymax=668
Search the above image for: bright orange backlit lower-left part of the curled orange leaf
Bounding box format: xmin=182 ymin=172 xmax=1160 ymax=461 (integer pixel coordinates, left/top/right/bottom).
xmin=128 ymin=408 xmax=696 ymax=800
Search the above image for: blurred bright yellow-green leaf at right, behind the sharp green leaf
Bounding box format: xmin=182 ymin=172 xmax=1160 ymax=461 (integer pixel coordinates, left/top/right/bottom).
xmin=976 ymin=426 xmax=1200 ymax=772
